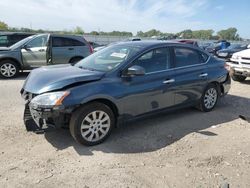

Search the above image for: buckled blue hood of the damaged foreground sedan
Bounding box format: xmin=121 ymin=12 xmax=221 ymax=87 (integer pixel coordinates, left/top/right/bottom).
xmin=23 ymin=65 xmax=104 ymax=94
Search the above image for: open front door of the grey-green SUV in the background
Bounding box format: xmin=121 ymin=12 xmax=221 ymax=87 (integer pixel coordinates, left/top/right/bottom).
xmin=21 ymin=34 xmax=49 ymax=68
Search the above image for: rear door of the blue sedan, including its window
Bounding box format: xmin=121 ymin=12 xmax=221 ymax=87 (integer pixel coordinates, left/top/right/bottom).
xmin=173 ymin=46 xmax=208 ymax=105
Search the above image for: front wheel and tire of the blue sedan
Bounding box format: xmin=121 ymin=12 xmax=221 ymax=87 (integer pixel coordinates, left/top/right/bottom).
xmin=69 ymin=102 xmax=115 ymax=146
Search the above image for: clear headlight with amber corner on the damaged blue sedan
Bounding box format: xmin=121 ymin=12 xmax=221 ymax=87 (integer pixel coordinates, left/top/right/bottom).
xmin=31 ymin=91 xmax=69 ymax=106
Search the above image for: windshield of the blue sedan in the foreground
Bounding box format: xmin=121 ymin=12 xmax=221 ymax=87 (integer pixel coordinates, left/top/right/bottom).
xmin=75 ymin=45 xmax=140 ymax=72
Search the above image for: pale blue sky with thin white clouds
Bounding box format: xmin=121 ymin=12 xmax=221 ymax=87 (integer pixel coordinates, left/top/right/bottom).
xmin=0 ymin=0 xmax=250 ymax=38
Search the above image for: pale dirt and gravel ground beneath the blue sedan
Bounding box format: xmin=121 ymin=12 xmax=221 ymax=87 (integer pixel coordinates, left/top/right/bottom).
xmin=0 ymin=76 xmax=250 ymax=187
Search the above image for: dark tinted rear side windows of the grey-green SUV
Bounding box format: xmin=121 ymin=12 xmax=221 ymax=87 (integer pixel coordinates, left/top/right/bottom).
xmin=52 ymin=37 xmax=85 ymax=47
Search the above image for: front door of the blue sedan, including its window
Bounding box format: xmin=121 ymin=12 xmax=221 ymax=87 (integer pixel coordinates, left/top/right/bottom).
xmin=121 ymin=47 xmax=174 ymax=116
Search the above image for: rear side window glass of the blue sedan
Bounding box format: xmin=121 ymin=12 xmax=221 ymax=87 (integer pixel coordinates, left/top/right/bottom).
xmin=174 ymin=47 xmax=204 ymax=67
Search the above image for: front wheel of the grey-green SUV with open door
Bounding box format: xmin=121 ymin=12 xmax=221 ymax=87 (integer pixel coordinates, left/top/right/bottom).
xmin=0 ymin=60 xmax=20 ymax=78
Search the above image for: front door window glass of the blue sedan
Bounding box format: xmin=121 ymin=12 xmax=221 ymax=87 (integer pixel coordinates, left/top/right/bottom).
xmin=135 ymin=48 xmax=171 ymax=73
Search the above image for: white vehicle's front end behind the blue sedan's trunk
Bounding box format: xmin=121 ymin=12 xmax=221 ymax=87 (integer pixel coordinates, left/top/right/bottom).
xmin=227 ymin=45 xmax=250 ymax=82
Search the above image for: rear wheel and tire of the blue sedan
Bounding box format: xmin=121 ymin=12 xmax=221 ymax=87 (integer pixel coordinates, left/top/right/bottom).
xmin=199 ymin=84 xmax=220 ymax=112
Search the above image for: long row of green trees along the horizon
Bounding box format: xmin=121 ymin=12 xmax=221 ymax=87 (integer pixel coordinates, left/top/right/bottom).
xmin=0 ymin=21 xmax=241 ymax=40
